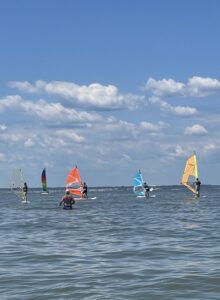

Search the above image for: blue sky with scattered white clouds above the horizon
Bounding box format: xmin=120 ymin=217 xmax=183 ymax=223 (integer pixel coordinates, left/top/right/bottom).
xmin=0 ymin=0 xmax=220 ymax=187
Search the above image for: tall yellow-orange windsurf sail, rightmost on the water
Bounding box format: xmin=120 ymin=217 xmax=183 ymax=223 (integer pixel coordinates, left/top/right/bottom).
xmin=182 ymin=153 xmax=199 ymax=194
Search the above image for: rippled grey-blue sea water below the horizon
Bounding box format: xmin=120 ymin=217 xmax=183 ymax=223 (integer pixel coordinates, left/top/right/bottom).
xmin=0 ymin=186 xmax=220 ymax=300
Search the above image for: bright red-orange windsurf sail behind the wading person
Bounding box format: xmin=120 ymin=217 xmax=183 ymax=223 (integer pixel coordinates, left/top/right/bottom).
xmin=66 ymin=166 xmax=82 ymax=197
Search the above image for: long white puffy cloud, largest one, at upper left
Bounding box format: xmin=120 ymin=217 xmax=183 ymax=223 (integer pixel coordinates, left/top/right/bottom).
xmin=8 ymin=80 xmax=144 ymax=110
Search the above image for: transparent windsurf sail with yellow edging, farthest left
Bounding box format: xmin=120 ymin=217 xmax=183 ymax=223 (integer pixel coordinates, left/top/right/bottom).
xmin=10 ymin=169 xmax=26 ymax=202
